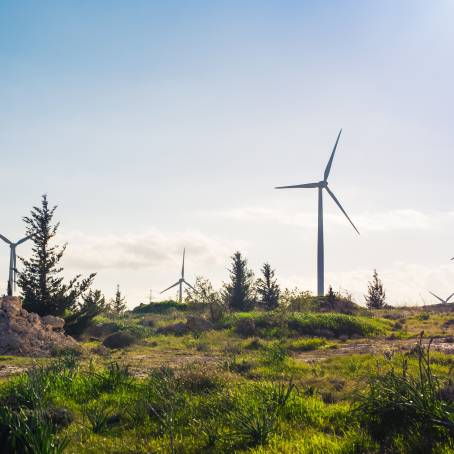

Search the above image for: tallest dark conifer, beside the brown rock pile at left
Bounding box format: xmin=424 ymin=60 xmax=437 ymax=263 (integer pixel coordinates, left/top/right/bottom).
xmin=18 ymin=195 xmax=105 ymax=329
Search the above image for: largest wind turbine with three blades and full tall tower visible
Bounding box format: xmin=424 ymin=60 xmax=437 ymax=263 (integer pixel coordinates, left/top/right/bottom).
xmin=275 ymin=129 xmax=359 ymax=296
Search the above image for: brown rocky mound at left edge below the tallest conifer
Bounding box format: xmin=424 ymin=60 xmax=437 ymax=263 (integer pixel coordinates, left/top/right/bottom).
xmin=0 ymin=296 xmax=78 ymax=356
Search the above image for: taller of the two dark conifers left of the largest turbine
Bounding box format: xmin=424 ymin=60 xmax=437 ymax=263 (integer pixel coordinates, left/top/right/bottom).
xmin=224 ymin=252 xmax=255 ymax=311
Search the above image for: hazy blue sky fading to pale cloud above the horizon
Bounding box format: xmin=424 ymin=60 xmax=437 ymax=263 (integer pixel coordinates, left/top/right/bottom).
xmin=0 ymin=0 xmax=454 ymax=306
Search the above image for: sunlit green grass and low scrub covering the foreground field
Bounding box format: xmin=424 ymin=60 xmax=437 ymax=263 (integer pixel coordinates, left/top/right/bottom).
xmin=0 ymin=304 xmax=454 ymax=454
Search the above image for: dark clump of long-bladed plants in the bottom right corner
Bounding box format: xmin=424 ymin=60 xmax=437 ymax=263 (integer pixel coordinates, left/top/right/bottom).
xmin=356 ymin=335 xmax=454 ymax=452
